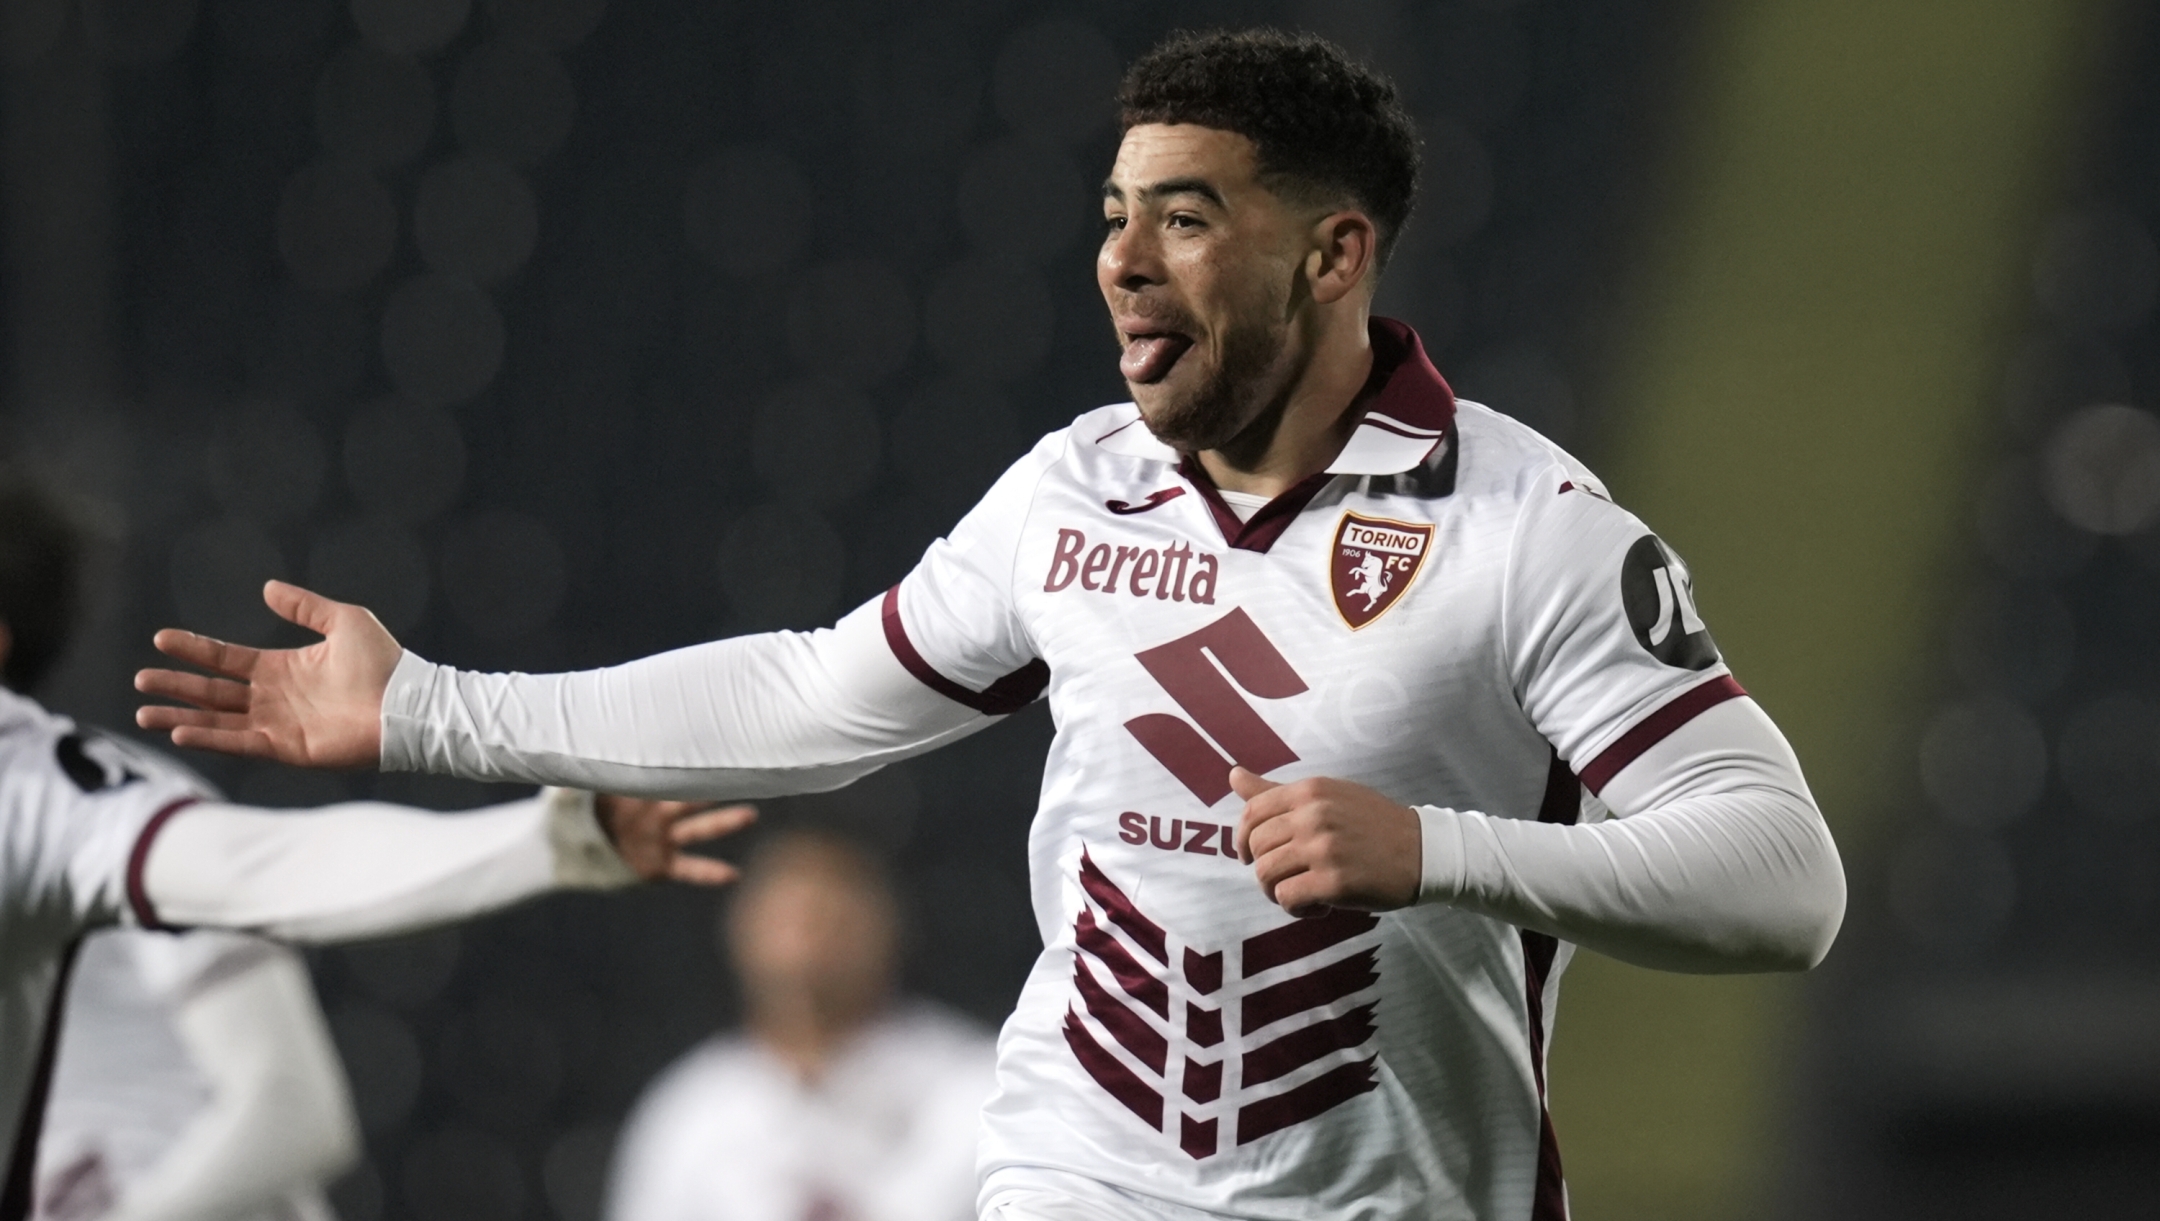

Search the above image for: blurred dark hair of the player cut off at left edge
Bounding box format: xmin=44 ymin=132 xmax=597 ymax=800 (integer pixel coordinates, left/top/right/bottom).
xmin=0 ymin=478 xmax=82 ymax=692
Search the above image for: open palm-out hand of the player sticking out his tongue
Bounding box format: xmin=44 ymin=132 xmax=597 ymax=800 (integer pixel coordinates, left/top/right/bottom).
xmin=136 ymin=581 xmax=404 ymax=767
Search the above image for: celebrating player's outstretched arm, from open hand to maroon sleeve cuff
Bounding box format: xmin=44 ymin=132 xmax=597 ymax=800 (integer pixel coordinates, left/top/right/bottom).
xmin=136 ymin=581 xmax=991 ymax=797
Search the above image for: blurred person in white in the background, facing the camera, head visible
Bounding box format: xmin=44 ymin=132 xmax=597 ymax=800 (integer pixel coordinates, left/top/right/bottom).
xmin=607 ymin=830 xmax=994 ymax=1221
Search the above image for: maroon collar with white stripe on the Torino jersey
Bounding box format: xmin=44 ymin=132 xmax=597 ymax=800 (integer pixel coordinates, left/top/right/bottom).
xmin=1177 ymin=318 xmax=1456 ymax=551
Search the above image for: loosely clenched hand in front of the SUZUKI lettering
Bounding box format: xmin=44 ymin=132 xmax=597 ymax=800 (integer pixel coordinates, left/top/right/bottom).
xmin=1229 ymin=767 xmax=1423 ymax=916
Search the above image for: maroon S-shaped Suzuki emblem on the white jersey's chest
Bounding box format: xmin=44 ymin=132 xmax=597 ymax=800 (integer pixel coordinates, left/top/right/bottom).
xmin=1125 ymin=607 xmax=1307 ymax=806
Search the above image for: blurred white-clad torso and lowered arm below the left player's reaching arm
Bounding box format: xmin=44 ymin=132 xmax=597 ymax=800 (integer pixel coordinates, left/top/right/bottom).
xmin=37 ymin=929 xmax=361 ymax=1221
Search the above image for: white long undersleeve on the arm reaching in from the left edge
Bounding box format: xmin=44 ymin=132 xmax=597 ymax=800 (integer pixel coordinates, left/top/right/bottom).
xmin=130 ymin=789 xmax=637 ymax=942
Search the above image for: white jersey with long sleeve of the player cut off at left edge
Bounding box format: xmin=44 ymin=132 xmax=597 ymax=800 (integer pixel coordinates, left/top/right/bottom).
xmin=0 ymin=689 xmax=635 ymax=1217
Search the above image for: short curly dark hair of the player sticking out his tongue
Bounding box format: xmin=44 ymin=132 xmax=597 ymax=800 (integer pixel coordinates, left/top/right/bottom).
xmin=1117 ymin=28 xmax=1417 ymax=268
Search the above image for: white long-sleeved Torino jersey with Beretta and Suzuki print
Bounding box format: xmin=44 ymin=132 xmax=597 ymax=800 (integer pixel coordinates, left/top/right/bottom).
xmin=382 ymin=320 xmax=1845 ymax=1221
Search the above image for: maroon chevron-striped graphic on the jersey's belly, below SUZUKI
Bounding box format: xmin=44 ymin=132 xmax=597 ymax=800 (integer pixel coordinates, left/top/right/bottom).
xmin=1065 ymin=849 xmax=1380 ymax=1158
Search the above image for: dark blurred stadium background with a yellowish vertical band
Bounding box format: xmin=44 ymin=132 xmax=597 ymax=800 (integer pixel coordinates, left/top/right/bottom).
xmin=0 ymin=0 xmax=2160 ymax=1221
